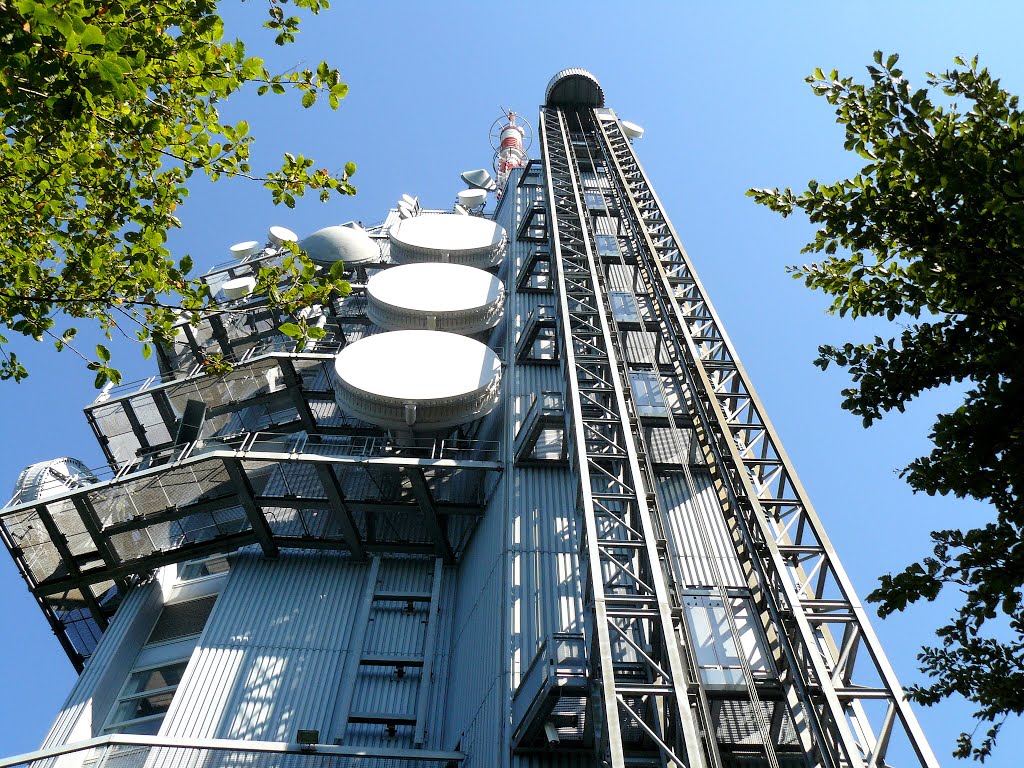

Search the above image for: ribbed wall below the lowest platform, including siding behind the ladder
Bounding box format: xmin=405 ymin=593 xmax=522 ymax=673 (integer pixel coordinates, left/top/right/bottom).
xmin=154 ymin=552 xmax=454 ymax=749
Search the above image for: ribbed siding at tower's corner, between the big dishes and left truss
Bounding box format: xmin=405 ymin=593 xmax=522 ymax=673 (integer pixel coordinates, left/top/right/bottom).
xmin=445 ymin=174 xmax=587 ymax=768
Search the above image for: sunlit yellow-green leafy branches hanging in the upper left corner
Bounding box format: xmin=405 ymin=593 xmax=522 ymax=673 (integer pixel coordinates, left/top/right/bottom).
xmin=0 ymin=0 xmax=355 ymax=387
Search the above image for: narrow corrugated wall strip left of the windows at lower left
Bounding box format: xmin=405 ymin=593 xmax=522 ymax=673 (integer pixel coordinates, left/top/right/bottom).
xmin=42 ymin=582 xmax=163 ymax=749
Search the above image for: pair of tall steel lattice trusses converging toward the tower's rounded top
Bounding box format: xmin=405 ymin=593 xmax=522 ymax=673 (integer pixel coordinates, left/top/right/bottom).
xmin=541 ymin=108 xmax=938 ymax=768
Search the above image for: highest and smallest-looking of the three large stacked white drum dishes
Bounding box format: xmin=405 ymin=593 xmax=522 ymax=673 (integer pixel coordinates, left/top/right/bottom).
xmin=388 ymin=213 xmax=505 ymax=267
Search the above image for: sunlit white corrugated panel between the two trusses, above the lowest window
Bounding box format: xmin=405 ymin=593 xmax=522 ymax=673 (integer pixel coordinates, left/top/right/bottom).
xmin=657 ymin=468 xmax=746 ymax=587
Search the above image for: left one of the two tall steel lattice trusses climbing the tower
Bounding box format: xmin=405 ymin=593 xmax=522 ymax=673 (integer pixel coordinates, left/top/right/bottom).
xmin=540 ymin=108 xmax=703 ymax=768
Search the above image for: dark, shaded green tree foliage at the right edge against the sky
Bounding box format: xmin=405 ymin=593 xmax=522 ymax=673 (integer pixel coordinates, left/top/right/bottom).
xmin=748 ymin=52 xmax=1024 ymax=760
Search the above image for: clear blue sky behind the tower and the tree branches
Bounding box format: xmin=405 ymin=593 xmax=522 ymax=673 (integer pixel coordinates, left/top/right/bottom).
xmin=0 ymin=0 xmax=1024 ymax=767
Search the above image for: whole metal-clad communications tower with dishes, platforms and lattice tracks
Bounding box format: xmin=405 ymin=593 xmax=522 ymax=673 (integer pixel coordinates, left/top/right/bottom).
xmin=0 ymin=69 xmax=937 ymax=768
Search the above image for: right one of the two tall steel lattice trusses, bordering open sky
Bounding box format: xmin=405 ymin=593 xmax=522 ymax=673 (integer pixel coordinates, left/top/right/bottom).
xmin=589 ymin=116 xmax=938 ymax=768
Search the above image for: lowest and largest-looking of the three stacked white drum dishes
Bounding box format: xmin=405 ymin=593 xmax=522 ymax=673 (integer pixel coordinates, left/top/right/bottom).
xmin=334 ymin=331 xmax=502 ymax=430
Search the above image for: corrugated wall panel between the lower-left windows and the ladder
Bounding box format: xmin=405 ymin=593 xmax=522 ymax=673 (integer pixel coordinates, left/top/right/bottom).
xmin=161 ymin=552 xmax=368 ymax=740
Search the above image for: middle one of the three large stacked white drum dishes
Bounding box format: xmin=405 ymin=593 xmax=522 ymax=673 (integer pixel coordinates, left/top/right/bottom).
xmin=367 ymin=262 xmax=505 ymax=334
